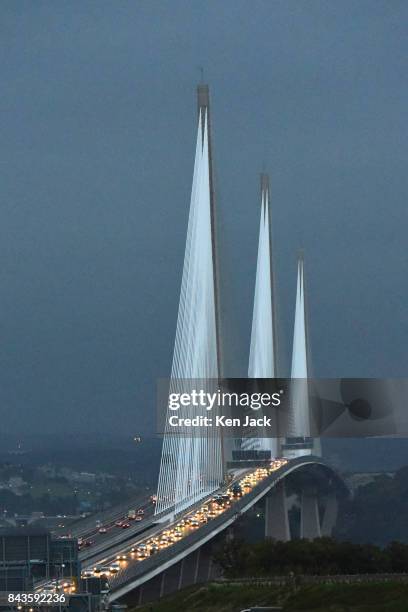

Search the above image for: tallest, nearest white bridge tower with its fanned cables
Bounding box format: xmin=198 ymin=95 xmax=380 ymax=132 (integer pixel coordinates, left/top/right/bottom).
xmin=156 ymin=89 xmax=224 ymax=514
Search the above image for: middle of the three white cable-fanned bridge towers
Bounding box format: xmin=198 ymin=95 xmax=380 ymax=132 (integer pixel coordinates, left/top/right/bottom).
xmin=241 ymin=173 xmax=278 ymax=458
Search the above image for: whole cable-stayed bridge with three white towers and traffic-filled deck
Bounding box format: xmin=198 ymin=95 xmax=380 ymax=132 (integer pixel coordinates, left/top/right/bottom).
xmin=48 ymin=85 xmax=346 ymax=603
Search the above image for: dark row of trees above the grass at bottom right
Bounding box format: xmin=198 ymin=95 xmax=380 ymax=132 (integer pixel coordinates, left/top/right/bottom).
xmin=214 ymin=538 xmax=408 ymax=578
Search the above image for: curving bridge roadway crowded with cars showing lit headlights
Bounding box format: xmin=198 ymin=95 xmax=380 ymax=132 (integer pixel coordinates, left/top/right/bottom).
xmin=42 ymin=455 xmax=345 ymax=601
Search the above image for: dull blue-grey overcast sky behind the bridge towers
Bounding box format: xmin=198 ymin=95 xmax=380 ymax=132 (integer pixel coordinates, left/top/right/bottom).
xmin=0 ymin=0 xmax=408 ymax=432
